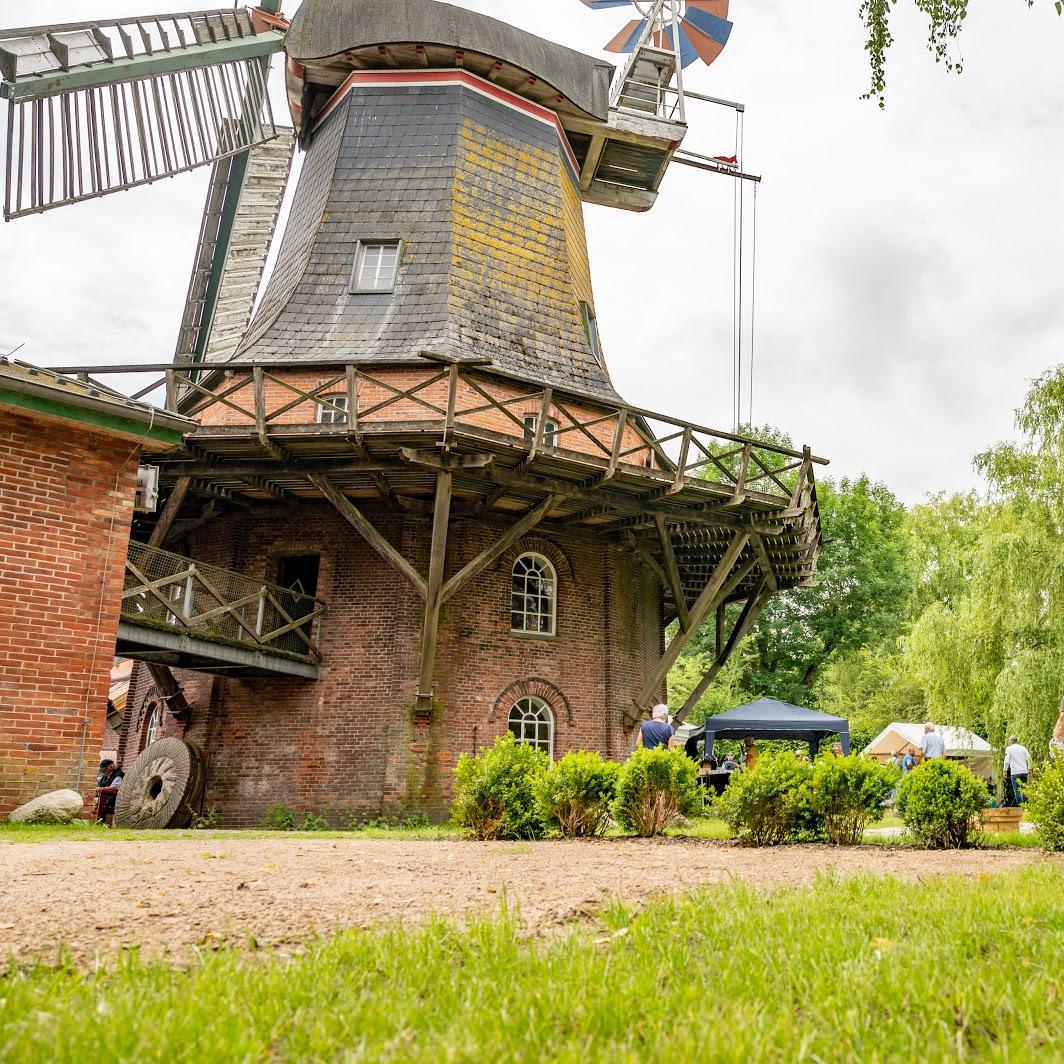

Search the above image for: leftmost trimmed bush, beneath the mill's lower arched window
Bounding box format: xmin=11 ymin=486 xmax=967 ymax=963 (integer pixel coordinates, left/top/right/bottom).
xmin=451 ymin=732 xmax=549 ymax=838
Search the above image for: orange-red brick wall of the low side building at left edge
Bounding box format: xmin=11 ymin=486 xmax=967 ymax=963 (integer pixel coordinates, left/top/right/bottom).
xmin=0 ymin=409 xmax=137 ymax=813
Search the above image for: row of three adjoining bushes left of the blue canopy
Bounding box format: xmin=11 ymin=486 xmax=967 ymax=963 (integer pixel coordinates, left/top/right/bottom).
xmin=452 ymin=734 xmax=699 ymax=838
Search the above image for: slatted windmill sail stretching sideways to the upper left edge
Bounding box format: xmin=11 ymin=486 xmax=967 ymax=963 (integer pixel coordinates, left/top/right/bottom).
xmin=0 ymin=10 xmax=284 ymax=219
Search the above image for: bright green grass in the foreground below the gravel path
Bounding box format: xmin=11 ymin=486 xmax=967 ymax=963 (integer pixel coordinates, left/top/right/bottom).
xmin=0 ymin=863 xmax=1064 ymax=1064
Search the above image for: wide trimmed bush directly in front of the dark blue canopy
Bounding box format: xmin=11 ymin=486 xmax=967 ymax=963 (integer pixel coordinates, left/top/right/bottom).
xmin=714 ymin=750 xmax=822 ymax=846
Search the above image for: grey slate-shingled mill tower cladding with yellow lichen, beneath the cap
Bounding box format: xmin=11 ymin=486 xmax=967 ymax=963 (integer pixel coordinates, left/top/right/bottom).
xmin=234 ymin=85 xmax=620 ymax=402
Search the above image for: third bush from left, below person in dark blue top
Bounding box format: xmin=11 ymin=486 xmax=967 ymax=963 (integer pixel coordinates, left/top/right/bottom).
xmin=613 ymin=747 xmax=700 ymax=838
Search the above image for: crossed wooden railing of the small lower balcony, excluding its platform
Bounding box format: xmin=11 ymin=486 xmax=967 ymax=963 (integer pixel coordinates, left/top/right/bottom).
xmin=121 ymin=542 xmax=326 ymax=663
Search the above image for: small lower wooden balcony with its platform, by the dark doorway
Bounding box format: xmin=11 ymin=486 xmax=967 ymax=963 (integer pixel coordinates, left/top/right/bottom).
xmin=117 ymin=543 xmax=325 ymax=680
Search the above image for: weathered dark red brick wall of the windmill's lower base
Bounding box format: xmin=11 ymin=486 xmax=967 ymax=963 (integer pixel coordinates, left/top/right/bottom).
xmin=122 ymin=503 xmax=662 ymax=826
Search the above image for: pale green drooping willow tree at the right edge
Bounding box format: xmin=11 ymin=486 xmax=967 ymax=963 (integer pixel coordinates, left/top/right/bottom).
xmin=908 ymin=367 xmax=1064 ymax=753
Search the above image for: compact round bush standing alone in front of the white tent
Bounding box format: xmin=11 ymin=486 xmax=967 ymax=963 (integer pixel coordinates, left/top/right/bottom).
xmin=895 ymin=758 xmax=990 ymax=849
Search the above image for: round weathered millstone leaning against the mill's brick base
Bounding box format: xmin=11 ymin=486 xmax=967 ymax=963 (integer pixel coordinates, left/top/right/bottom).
xmin=115 ymin=737 xmax=203 ymax=828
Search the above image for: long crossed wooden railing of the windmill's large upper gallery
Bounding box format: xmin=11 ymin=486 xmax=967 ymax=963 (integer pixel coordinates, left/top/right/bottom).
xmin=57 ymin=359 xmax=827 ymax=508
